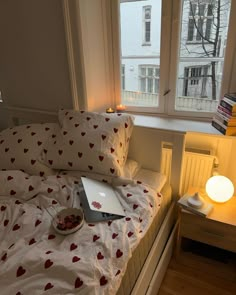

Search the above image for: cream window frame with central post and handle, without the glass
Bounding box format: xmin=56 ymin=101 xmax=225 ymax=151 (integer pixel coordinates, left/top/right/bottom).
xmin=113 ymin=0 xmax=236 ymax=120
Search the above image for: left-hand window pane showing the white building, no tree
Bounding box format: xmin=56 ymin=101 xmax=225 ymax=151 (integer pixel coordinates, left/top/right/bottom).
xmin=120 ymin=0 xmax=162 ymax=107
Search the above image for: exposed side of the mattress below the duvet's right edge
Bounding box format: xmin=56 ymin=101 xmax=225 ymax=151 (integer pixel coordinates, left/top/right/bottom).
xmin=117 ymin=182 xmax=172 ymax=295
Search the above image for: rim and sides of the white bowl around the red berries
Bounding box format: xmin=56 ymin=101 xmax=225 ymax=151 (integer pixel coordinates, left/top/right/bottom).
xmin=52 ymin=208 xmax=84 ymax=235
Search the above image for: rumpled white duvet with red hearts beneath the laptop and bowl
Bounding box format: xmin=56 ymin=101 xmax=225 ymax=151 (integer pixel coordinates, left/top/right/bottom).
xmin=0 ymin=171 xmax=162 ymax=295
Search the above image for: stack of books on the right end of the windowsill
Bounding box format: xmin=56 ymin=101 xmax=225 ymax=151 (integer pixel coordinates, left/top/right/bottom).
xmin=211 ymin=93 xmax=236 ymax=135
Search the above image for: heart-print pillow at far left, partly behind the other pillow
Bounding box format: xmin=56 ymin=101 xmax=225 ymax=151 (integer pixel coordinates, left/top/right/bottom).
xmin=0 ymin=123 xmax=59 ymax=176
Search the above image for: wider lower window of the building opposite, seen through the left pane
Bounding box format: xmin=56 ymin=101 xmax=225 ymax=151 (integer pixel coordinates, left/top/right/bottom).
xmin=139 ymin=65 xmax=159 ymax=94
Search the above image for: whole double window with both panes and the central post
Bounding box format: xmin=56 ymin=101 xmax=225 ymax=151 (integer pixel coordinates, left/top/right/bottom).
xmin=119 ymin=0 xmax=233 ymax=118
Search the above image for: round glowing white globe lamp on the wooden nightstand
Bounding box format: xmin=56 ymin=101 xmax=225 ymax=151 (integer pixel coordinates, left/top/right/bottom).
xmin=206 ymin=175 xmax=234 ymax=203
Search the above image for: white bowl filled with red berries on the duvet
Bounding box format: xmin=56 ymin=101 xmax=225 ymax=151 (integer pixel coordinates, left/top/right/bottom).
xmin=52 ymin=208 xmax=84 ymax=235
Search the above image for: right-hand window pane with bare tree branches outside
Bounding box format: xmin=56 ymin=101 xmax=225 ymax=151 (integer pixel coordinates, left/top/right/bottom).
xmin=175 ymin=0 xmax=231 ymax=112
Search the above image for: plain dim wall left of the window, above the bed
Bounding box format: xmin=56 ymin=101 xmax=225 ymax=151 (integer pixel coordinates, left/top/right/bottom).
xmin=0 ymin=0 xmax=72 ymax=111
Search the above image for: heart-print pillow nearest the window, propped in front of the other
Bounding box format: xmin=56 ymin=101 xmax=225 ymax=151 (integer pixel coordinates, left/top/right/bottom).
xmin=40 ymin=110 xmax=133 ymax=176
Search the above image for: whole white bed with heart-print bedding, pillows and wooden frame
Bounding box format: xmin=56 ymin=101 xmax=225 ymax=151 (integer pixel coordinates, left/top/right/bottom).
xmin=0 ymin=110 xmax=184 ymax=295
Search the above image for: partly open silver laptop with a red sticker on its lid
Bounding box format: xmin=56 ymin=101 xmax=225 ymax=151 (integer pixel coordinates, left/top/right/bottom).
xmin=80 ymin=177 xmax=125 ymax=222
